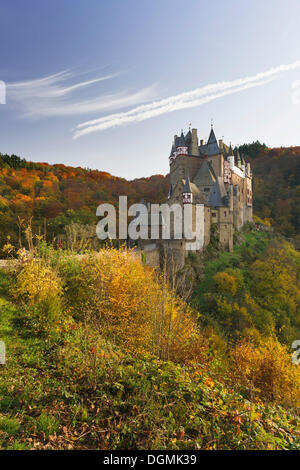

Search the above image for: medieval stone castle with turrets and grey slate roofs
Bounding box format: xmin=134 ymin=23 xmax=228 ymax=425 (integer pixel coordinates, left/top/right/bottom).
xmin=140 ymin=126 xmax=252 ymax=265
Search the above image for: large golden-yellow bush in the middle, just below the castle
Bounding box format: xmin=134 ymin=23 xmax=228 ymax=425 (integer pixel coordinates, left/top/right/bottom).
xmin=74 ymin=249 xmax=212 ymax=362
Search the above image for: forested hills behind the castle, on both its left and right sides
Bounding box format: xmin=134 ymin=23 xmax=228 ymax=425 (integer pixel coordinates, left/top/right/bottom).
xmin=0 ymin=142 xmax=300 ymax=252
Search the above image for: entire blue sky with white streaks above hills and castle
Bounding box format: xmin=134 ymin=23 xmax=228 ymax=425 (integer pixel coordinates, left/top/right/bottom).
xmin=0 ymin=0 xmax=300 ymax=179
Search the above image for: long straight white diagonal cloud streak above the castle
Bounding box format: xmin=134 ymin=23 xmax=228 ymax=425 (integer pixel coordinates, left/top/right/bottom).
xmin=73 ymin=61 xmax=300 ymax=139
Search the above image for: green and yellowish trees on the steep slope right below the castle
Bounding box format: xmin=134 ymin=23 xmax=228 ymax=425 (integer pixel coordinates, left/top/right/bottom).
xmin=192 ymin=228 xmax=300 ymax=345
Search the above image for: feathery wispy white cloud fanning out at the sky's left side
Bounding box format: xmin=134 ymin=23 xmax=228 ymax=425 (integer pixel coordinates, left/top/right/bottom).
xmin=6 ymin=70 xmax=155 ymax=117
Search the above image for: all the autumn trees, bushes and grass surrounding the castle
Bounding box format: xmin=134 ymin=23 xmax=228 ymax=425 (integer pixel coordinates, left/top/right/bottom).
xmin=0 ymin=142 xmax=300 ymax=451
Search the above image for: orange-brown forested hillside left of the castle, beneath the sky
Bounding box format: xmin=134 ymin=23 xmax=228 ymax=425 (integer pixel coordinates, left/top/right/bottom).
xmin=0 ymin=154 xmax=169 ymax=248
